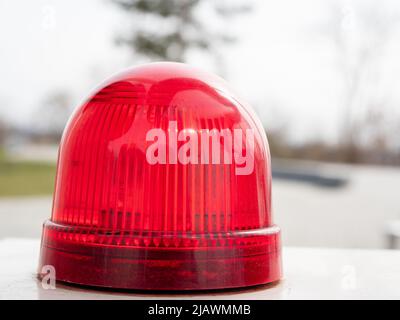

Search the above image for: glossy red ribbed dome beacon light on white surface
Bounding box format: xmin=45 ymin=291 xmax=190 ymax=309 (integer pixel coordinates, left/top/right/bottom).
xmin=39 ymin=63 xmax=282 ymax=290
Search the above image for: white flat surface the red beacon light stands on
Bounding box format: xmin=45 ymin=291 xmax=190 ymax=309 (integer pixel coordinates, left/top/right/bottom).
xmin=0 ymin=239 xmax=400 ymax=299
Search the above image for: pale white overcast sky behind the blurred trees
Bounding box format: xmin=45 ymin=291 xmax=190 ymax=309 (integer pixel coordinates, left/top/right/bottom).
xmin=0 ymin=0 xmax=400 ymax=140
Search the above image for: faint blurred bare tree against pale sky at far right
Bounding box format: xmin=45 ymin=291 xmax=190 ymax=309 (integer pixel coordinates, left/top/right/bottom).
xmin=322 ymin=1 xmax=398 ymax=162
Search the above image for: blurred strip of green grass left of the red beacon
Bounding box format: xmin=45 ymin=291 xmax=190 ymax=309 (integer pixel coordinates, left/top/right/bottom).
xmin=0 ymin=151 xmax=56 ymax=197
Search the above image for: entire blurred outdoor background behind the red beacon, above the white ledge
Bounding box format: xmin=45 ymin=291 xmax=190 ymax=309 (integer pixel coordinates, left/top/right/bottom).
xmin=0 ymin=0 xmax=400 ymax=249
